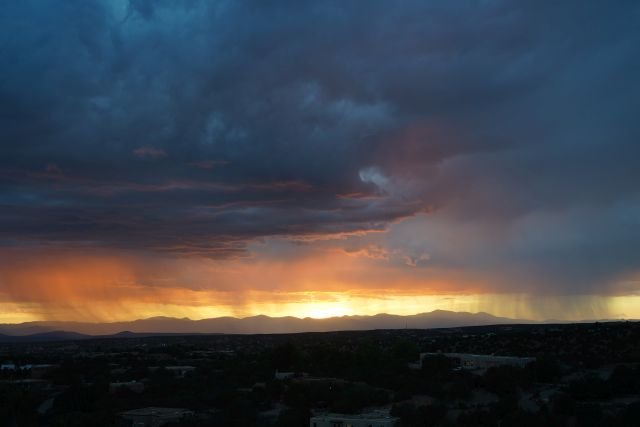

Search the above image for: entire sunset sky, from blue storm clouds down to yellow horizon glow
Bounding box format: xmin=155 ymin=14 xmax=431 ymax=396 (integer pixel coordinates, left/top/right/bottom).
xmin=0 ymin=0 xmax=640 ymax=323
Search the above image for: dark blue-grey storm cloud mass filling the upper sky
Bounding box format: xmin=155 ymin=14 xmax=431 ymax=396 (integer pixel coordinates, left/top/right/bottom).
xmin=0 ymin=0 xmax=640 ymax=290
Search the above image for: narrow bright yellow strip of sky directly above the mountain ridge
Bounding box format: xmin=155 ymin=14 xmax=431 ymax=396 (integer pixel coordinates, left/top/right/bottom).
xmin=0 ymin=290 xmax=640 ymax=323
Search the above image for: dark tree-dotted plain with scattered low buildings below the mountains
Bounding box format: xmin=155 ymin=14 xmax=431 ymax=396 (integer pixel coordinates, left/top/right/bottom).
xmin=0 ymin=322 xmax=640 ymax=427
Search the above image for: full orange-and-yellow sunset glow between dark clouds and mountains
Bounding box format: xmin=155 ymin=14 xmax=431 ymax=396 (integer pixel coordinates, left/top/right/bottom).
xmin=0 ymin=244 xmax=640 ymax=323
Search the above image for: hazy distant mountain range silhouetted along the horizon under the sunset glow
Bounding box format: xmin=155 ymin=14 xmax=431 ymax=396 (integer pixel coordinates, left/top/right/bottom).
xmin=0 ymin=310 xmax=533 ymax=340
